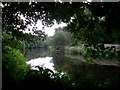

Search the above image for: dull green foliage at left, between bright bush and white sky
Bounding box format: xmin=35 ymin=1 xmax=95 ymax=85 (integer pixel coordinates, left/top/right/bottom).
xmin=2 ymin=29 xmax=45 ymax=52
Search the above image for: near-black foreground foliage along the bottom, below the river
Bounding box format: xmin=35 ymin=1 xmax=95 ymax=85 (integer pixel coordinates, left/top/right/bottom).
xmin=20 ymin=66 xmax=119 ymax=90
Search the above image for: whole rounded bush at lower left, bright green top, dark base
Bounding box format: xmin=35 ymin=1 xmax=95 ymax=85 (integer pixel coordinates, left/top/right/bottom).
xmin=2 ymin=46 xmax=28 ymax=89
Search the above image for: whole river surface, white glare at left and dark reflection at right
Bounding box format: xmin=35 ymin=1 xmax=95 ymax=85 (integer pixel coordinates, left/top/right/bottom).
xmin=26 ymin=49 xmax=120 ymax=87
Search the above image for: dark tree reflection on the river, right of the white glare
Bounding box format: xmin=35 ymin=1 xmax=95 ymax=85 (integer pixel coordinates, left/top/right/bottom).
xmin=25 ymin=48 xmax=120 ymax=88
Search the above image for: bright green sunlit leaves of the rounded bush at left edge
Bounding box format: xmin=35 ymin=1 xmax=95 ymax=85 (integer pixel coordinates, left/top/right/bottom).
xmin=3 ymin=46 xmax=28 ymax=80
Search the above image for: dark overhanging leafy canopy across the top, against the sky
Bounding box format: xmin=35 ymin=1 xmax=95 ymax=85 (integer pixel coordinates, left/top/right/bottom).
xmin=2 ymin=2 xmax=120 ymax=44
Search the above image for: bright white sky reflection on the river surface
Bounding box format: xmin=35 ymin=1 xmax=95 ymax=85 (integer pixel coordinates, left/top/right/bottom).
xmin=27 ymin=57 xmax=54 ymax=71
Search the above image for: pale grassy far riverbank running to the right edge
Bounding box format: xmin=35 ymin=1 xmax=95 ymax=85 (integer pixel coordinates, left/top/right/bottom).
xmin=65 ymin=44 xmax=120 ymax=67
